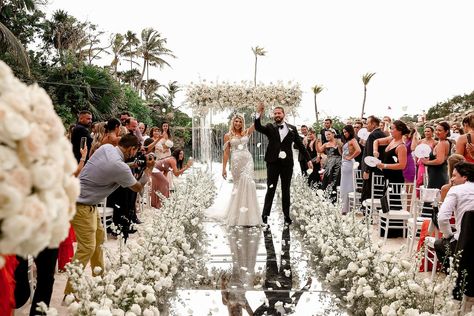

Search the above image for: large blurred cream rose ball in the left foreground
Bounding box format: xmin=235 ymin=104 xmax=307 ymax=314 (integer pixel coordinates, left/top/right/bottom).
xmin=0 ymin=61 xmax=79 ymax=268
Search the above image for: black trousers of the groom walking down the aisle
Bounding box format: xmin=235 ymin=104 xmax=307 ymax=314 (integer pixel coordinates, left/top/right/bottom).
xmin=262 ymin=159 xmax=293 ymax=222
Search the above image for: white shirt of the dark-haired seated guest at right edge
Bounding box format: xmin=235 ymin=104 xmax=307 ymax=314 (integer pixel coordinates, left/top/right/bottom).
xmin=438 ymin=182 xmax=474 ymax=240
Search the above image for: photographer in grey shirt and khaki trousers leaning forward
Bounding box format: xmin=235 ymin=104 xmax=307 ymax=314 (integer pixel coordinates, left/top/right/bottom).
xmin=64 ymin=135 xmax=155 ymax=294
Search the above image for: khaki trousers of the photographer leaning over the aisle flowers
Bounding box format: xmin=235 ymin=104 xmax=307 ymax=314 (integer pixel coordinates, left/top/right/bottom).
xmin=64 ymin=203 xmax=104 ymax=294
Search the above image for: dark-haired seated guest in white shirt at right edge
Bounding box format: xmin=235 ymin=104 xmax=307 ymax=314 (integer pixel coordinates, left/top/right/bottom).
xmin=435 ymin=161 xmax=474 ymax=267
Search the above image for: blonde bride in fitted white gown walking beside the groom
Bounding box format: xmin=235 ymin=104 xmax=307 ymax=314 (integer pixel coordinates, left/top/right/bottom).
xmin=222 ymin=114 xmax=263 ymax=226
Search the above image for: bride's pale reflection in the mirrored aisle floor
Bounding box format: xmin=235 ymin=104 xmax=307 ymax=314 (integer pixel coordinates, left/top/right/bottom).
xmin=221 ymin=227 xmax=261 ymax=316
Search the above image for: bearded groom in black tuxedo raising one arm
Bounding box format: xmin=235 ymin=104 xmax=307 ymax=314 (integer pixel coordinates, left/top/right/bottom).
xmin=255 ymin=103 xmax=313 ymax=224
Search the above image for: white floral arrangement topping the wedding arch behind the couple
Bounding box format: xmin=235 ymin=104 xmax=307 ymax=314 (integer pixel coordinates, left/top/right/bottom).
xmin=185 ymin=81 xmax=302 ymax=115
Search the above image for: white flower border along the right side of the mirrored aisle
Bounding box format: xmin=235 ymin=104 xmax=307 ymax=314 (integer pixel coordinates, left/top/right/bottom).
xmin=291 ymin=178 xmax=472 ymax=315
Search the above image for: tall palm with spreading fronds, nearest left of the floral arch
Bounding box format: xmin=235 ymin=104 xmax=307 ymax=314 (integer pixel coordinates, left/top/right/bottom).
xmin=137 ymin=28 xmax=175 ymax=89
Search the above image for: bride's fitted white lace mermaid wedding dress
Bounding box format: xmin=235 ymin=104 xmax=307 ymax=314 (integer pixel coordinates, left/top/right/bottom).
xmin=225 ymin=136 xmax=263 ymax=226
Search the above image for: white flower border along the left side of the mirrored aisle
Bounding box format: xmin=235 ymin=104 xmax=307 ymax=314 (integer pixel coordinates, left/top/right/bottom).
xmin=66 ymin=172 xmax=216 ymax=316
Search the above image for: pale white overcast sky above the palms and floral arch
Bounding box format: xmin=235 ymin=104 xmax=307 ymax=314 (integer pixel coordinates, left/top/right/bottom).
xmin=46 ymin=0 xmax=474 ymax=124
